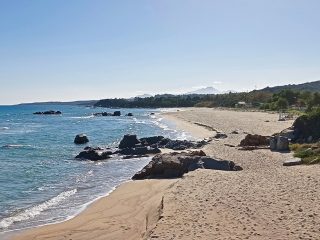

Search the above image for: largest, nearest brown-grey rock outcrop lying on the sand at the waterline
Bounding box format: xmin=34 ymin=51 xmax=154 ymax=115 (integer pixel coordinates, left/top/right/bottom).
xmin=132 ymin=151 xmax=242 ymax=180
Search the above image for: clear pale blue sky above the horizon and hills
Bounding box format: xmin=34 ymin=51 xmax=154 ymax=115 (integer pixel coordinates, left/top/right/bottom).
xmin=0 ymin=0 xmax=320 ymax=104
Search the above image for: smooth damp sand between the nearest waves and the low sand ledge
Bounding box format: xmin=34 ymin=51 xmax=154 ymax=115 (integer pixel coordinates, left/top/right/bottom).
xmin=5 ymin=179 xmax=178 ymax=240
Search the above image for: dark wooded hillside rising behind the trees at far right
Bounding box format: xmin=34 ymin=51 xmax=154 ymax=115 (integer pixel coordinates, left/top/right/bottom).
xmin=257 ymin=80 xmax=320 ymax=93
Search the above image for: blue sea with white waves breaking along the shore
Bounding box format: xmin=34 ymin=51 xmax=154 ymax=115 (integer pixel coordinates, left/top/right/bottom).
xmin=0 ymin=105 xmax=192 ymax=235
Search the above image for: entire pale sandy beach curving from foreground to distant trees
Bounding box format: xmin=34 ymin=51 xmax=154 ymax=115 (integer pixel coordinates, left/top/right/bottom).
xmin=12 ymin=108 xmax=320 ymax=240
